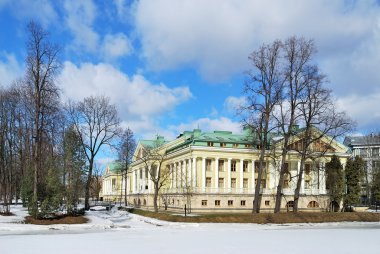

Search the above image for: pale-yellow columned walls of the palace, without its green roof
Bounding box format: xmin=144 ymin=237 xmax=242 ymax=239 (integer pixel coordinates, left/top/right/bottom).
xmin=127 ymin=129 xmax=349 ymax=212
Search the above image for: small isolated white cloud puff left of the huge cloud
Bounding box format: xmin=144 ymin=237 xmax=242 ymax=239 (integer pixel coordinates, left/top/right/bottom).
xmin=103 ymin=33 xmax=133 ymax=60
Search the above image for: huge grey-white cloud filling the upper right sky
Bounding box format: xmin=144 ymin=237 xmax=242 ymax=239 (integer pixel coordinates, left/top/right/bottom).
xmin=135 ymin=0 xmax=380 ymax=88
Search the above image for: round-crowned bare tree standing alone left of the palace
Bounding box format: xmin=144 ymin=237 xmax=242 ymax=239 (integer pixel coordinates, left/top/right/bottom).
xmin=68 ymin=96 xmax=120 ymax=210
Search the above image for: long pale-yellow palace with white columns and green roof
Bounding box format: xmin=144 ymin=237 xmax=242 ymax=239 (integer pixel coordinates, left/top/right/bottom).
xmin=113 ymin=128 xmax=350 ymax=213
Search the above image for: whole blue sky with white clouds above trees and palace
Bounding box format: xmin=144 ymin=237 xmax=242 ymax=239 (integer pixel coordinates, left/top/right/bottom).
xmin=0 ymin=0 xmax=380 ymax=143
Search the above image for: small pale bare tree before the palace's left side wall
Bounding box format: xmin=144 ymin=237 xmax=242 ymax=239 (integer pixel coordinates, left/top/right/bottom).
xmin=140 ymin=139 xmax=170 ymax=212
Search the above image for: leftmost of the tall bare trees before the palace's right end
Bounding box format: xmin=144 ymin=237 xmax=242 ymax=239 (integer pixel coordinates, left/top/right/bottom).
xmin=239 ymin=40 xmax=282 ymax=213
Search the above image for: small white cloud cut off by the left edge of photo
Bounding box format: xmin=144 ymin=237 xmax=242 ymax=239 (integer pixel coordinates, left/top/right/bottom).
xmin=0 ymin=52 xmax=23 ymax=86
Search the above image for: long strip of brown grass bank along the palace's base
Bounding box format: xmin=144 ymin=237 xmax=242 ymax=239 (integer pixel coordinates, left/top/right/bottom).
xmin=131 ymin=209 xmax=380 ymax=224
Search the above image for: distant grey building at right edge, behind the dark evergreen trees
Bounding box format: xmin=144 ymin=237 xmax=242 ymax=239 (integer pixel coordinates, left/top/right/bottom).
xmin=343 ymin=135 xmax=380 ymax=204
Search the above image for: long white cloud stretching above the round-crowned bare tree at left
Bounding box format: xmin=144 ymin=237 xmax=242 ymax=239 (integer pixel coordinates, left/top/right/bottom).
xmin=58 ymin=62 xmax=192 ymax=133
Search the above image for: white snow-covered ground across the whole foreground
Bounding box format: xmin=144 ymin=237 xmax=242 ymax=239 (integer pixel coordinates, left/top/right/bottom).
xmin=0 ymin=207 xmax=380 ymax=254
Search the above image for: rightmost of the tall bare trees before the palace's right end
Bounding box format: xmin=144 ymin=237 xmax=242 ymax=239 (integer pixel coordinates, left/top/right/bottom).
xmin=290 ymin=66 xmax=353 ymax=212
